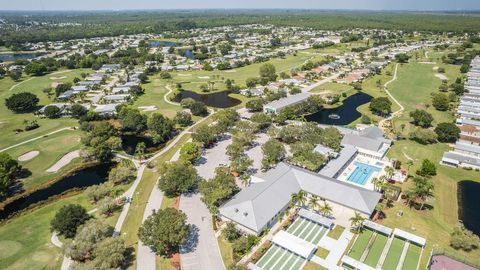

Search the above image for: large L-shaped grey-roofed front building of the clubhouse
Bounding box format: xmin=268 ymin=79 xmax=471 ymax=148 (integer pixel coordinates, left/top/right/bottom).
xmin=219 ymin=162 xmax=382 ymax=235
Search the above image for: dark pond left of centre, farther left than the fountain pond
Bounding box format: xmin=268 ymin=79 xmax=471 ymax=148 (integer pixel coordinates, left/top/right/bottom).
xmin=173 ymin=90 xmax=242 ymax=108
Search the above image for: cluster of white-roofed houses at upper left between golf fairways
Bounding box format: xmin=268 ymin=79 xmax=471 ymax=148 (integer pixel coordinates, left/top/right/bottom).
xmin=37 ymin=64 xmax=144 ymax=117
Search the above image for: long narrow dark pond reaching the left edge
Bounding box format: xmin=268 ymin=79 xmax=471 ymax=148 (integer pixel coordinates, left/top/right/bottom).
xmin=0 ymin=163 xmax=114 ymax=220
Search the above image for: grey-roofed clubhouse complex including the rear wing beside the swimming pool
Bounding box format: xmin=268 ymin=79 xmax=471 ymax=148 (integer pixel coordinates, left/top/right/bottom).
xmin=219 ymin=127 xmax=392 ymax=235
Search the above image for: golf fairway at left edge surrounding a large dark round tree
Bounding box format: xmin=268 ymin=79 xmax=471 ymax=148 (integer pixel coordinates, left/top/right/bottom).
xmin=0 ymin=69 xmax=91 ymax=148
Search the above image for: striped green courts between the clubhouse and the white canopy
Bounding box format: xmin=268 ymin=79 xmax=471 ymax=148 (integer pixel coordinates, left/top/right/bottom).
xmin=287 ymin=217 xmax=328 ymax=245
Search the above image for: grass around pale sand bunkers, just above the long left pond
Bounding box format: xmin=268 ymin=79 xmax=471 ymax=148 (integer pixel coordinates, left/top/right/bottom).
xmin=1 ymin=130 xmax=81 ymax=194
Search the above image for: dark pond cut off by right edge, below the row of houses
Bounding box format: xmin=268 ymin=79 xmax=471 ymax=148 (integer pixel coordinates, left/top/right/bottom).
xmin=457 ymin=180 xmax=480 ymax=236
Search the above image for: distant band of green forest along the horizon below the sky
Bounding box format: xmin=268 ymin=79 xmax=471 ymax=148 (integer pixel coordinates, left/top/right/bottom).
xmin=0 ymin=10 xmax=480 ymax=46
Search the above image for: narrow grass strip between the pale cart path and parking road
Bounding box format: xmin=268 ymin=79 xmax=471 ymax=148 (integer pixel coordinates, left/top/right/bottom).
xmin=122 ymin=134 xmax=190 ymax=269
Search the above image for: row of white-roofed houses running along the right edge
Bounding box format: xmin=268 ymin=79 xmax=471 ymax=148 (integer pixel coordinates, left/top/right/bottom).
xmin=441 ymin=56 xmax=480 ymax=169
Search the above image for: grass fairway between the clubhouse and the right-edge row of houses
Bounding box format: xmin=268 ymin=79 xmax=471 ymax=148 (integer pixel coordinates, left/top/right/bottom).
xmin=382 ymin=50 xmax=480 ymax=269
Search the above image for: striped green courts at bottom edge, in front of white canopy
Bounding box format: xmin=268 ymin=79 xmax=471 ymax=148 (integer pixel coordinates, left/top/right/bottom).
xmin=256 ymin=244 xmax=306 ymax=270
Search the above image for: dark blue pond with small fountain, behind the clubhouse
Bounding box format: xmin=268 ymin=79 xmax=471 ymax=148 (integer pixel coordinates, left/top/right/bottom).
xmin=305 ymin=92 xmax=372 ymax=126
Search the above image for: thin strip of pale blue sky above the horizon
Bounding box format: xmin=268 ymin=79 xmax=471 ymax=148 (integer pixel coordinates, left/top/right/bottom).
xmin=0 ymin=0 xmax=480 ymax=10
